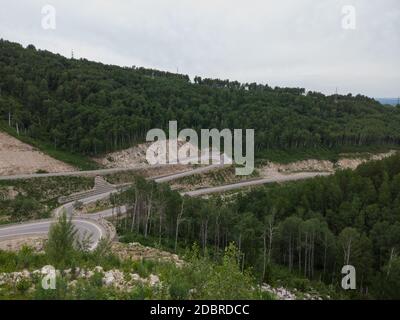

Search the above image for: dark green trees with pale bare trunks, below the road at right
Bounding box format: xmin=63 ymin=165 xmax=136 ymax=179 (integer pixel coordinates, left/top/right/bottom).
xmin=108 ymin=155 xmax=400 ymax=298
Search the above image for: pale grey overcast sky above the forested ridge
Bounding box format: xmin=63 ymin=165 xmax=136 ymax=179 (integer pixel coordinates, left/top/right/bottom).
xmin=0 ymin=0 xmax=400 ymax=97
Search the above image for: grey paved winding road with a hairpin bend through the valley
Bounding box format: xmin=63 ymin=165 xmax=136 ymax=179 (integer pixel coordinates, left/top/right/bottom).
xmin=0 ymin=164 xmax=330 ymax=249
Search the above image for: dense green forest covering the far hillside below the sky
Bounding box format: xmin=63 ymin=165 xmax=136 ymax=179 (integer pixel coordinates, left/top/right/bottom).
xmin=0 ymin=40 xmax=400 ymax=159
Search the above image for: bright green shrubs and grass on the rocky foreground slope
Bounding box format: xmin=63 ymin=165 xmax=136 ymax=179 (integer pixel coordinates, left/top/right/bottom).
xmin=0 ymin=216 xmax=273 ymax=299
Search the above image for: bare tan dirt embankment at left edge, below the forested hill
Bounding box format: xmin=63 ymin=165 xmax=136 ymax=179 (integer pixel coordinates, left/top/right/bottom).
xmin=0 ymin=132 xmax=75 ymax=176
